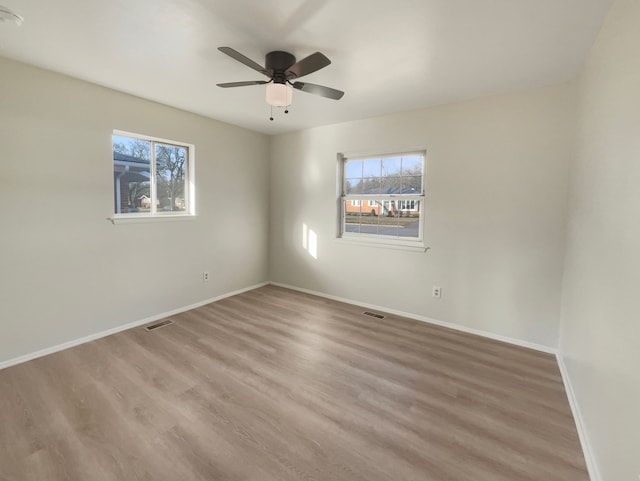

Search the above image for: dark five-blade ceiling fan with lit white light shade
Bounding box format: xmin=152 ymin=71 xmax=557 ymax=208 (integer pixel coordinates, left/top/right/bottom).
xmin=217 ymin=47 xmax=344 ymax=115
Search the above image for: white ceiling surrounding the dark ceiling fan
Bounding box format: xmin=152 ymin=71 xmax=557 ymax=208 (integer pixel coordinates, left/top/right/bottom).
xmin=0 ymin=0 xmax=611 ymax=134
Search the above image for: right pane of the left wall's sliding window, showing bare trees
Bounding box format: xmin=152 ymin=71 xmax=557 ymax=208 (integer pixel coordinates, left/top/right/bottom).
xmin=155 ymin=144 xmax=187 ymax=212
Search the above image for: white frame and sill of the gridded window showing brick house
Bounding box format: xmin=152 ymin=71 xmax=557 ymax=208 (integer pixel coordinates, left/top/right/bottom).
xmin=336 ymin=149 xmax=428 ymax=252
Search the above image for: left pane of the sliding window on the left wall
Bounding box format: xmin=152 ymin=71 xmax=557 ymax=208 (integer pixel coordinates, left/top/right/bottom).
xmin=113 ymin=135 xmax=151 ymax=214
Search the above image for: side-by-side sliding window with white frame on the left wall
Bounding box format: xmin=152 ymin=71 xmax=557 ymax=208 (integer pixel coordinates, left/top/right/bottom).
xmin=112 ymin=131 xmax=195 ymax=219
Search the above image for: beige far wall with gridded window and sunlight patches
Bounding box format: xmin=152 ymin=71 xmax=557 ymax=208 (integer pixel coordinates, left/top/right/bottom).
xmin=270 ymin=84 xmax=575 ymax=347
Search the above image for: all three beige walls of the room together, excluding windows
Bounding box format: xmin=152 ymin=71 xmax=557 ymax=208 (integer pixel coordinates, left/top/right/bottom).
xmin=0 ymin=9 xmax=640 ymax=474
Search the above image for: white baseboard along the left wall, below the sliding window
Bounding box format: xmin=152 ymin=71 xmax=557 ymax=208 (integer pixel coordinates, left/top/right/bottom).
xmin=0 ymin=282 xmax=269 ymax=369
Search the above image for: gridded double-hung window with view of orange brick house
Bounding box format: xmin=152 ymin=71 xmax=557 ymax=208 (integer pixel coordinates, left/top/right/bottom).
xmin=339 ymin=152 xmax=425 ymax=247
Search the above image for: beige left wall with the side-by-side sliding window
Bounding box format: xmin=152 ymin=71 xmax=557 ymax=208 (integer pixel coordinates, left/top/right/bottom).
xmin=0 ymin=59 xmax=268 ymax=362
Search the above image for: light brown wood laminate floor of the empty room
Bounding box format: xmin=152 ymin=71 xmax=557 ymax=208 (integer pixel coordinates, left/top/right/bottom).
xmin=0 ymin=286 xmax=588 ymax=481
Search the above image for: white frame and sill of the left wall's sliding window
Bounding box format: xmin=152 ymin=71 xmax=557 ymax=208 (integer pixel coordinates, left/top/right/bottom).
xmin=108 ymin=129 xmax=196 ymax=224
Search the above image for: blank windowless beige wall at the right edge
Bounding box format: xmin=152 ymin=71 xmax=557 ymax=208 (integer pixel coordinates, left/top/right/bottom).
xmin=560 ymin=0 xmax=640 ymax=481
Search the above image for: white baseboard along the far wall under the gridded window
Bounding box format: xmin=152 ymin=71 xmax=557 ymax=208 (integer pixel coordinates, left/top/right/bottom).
xmin=269 ymin=282 xmax=557 ymax=355
